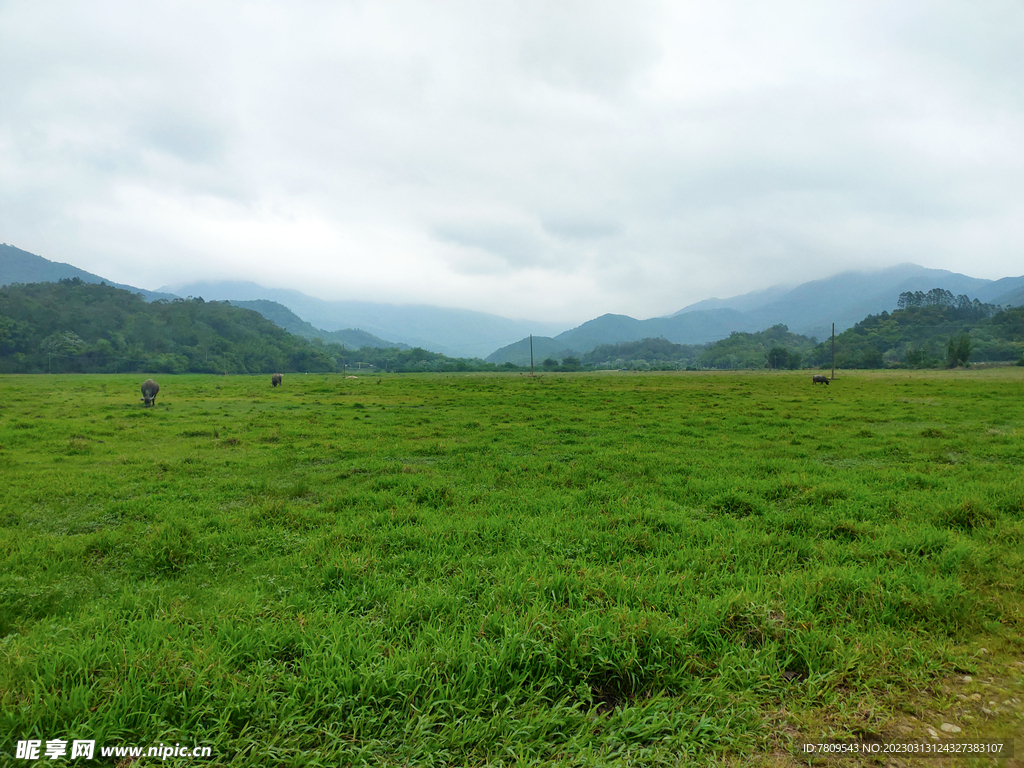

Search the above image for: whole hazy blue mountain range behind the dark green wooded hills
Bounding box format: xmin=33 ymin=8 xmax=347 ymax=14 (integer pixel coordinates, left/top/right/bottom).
xmin=0 ymin=245 xmax=1024 ymax=365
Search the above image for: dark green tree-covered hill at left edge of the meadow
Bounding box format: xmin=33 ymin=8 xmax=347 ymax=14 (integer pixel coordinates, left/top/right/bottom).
xmin=0 ymin=279 xmax=335 ymax=374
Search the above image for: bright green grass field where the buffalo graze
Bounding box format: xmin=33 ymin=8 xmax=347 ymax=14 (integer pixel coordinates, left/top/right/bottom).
xmin=0 ymin=368 xmax=1024 ymax=766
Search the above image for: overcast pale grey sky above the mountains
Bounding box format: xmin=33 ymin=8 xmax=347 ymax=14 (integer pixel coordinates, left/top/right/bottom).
xmin=0 ymin=0 xmax=1024 ymax=323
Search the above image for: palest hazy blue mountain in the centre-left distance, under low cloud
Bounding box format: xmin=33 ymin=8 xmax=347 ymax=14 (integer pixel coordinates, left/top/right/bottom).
xmin=161 ymin=283 xmax=564 ymax=362
